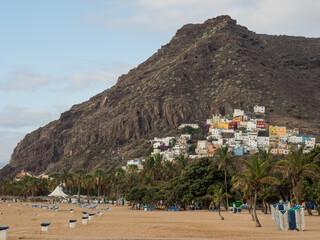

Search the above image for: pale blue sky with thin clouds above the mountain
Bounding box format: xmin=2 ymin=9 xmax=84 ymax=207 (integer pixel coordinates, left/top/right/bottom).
xmin=0 ymin=0 xmax=320 ymax=168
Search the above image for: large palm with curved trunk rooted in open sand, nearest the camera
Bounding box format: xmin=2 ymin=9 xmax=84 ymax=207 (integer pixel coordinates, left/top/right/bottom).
xmin=232 ymin=154 xmax=279 ymax=227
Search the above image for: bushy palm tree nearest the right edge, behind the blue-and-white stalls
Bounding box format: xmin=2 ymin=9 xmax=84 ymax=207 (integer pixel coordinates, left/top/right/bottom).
xmin=278 ymin=144 xmax=320 ymax=205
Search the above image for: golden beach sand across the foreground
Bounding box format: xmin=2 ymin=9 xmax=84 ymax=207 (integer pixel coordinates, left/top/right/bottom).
xmin=0 ymin=202 xmax=320 ymax=240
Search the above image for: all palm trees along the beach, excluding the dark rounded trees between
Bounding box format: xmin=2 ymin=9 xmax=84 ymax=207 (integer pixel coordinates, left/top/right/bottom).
xmin=0 ymin=142 xmax=320 ymax=227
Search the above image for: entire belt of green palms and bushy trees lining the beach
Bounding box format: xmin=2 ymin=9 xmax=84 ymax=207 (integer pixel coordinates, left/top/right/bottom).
xmin=0 ymin=146 xmax=320 ymax=223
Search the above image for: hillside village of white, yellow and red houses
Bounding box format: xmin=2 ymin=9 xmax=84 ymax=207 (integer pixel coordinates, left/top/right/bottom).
xmin=123 ymin=106 xmax=320 ymax=172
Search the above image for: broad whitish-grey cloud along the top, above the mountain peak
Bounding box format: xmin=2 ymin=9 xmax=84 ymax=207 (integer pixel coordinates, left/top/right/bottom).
xmin=85 ymin=0 xmax=320 ymax=36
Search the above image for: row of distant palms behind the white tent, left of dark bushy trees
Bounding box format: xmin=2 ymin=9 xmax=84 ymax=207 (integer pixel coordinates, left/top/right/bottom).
xmin=0 ymin=154 xmax=189 ymax=203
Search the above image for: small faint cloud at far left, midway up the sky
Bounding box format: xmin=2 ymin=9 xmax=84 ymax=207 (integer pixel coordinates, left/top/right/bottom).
xmin=5 ymin=68 xmax=50 ymax=90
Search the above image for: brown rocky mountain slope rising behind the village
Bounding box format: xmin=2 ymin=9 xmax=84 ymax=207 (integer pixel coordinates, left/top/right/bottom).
xmin=0 ymin=16 xmax=320 ymax=176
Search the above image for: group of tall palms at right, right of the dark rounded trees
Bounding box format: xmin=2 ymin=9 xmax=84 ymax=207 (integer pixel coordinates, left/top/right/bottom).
xmin=214 ymin=145 xmax=320 ymax=227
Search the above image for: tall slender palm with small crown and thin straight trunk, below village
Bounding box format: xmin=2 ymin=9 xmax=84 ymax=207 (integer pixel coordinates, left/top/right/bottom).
xmin=214 ymin=145 xmax=233 ymax=209
